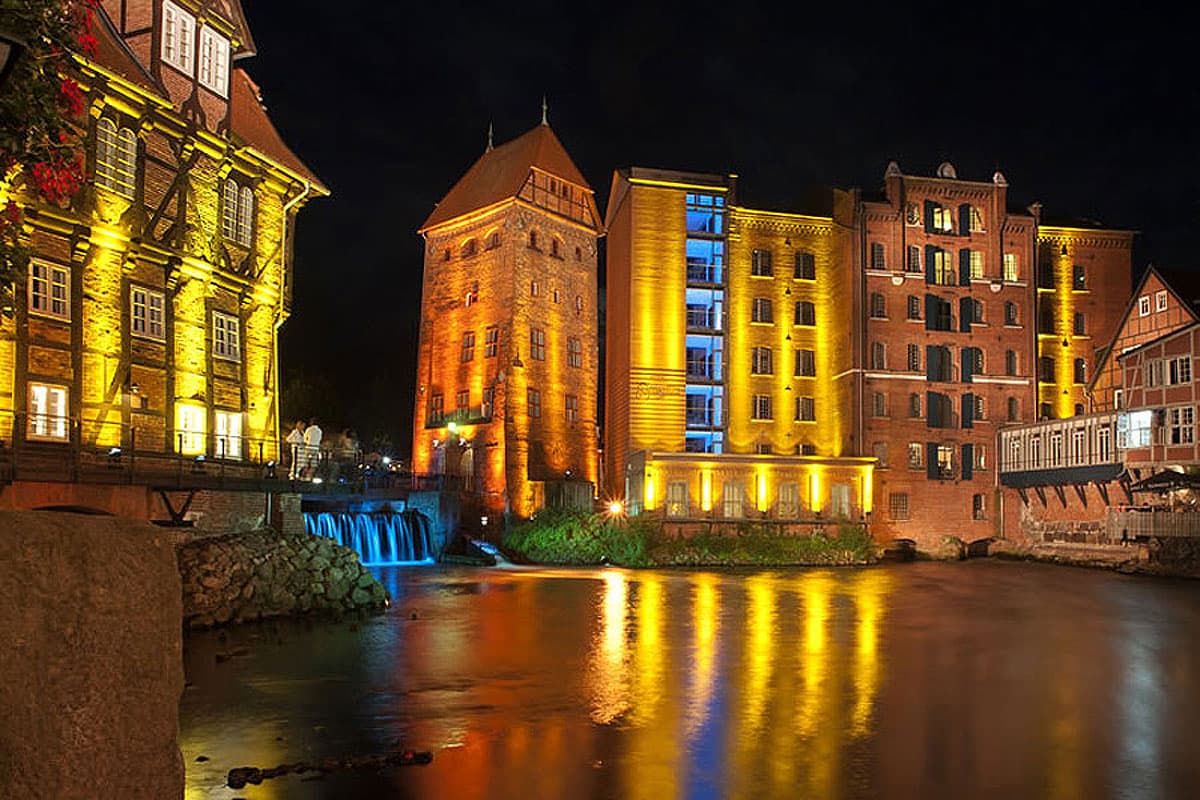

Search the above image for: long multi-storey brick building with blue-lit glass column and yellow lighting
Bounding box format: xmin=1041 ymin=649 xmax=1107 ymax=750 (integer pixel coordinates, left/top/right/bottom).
xmin=605 ymin=163 xmax=1133 ymax=545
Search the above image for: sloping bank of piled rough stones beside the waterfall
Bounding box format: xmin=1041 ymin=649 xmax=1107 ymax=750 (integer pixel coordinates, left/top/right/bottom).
xmin=179 ymin=530 xmax=388 ymax=627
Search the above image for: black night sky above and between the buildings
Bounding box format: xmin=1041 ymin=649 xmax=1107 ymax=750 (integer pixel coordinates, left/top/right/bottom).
xmin=241 ymin=0 xmax=1200 ymax=452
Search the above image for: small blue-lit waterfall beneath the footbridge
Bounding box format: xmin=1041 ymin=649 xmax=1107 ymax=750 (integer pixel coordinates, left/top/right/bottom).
xmin=304 ymin=511 xmax=437 ymax=566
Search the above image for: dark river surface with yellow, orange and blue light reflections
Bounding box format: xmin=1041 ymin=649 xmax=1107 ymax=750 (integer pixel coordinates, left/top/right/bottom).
xmin=180 ymin=561 xmax=1200 ymax=800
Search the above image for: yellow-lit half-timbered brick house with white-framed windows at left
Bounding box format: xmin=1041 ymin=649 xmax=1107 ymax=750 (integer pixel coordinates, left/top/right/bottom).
xmin=0 ymin=0 xmax=329 ymax=470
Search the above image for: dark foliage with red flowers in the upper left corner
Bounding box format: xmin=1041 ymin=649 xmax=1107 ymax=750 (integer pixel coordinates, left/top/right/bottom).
xmin=0 ymin=0 xmax=100 ymax=287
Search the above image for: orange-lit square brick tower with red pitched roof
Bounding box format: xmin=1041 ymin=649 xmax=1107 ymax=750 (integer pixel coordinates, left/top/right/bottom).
xmin=413 ymin=116 xmax=600 ymax=517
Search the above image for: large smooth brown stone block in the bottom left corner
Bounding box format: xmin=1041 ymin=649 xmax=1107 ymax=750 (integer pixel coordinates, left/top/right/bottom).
xmin=0 ymin=511 xmax=184 ymax=800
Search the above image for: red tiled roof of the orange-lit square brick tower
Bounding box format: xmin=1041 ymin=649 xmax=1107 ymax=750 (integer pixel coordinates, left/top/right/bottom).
xmin=418 ymin=122 xmax=592 ymax=233
